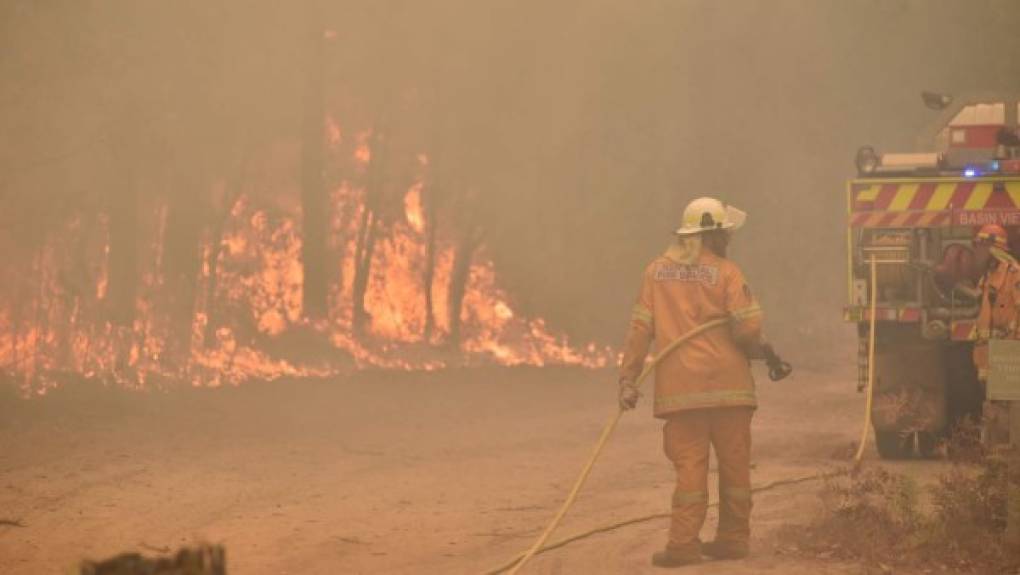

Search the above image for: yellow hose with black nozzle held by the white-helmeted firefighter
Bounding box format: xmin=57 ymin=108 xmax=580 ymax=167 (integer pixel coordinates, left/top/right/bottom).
xmin=487 ymin=317 xmax=793 ymax=575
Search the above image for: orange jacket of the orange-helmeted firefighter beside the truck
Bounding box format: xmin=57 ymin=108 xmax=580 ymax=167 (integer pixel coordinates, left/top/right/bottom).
xmin=974 ymin=252 xmax=1020 ymax=381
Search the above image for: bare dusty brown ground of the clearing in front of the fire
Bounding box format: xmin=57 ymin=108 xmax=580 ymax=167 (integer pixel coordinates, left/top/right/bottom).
xmin=0 ymin=361 xmax=954 ymax=575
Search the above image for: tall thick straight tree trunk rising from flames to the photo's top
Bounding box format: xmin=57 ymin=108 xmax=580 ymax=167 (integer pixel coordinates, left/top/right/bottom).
xmin=301 ymin=2 xmax=329 ymax=319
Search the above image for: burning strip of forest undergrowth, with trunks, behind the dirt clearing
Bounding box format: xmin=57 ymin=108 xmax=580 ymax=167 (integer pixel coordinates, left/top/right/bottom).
xmin=0 ymin=127 xmax=612 ymax=394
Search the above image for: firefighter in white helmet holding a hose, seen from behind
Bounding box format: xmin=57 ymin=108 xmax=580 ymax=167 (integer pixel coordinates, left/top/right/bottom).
xmin=619 ymin=198 xmax=762 ymax=567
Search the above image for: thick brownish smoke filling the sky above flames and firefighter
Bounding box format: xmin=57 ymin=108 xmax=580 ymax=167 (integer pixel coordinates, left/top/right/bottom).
xmin=0 ymin=0 xmax=1020 ymax=354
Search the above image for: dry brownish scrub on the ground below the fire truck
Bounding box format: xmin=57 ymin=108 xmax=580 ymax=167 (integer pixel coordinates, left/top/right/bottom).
xmin=780 ymin=457 xmax=1020 ymax=573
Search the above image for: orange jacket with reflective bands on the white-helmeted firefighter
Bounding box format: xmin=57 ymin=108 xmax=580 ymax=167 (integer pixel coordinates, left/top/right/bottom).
xmin=620 ymin=246 xmax=762 ymax=418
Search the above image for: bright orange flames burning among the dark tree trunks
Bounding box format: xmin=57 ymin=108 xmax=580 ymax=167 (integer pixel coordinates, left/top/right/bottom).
xmin=0 ymin=119 xmax=614 ymax=394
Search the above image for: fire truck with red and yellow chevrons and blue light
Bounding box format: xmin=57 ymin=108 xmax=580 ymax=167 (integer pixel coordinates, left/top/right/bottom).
xmin=844 ymin=93 xmax=1020 ymax=459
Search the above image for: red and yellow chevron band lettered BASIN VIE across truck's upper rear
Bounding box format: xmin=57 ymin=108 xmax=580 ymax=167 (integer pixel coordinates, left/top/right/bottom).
xmin=851 ymin=178 xmax=1020 ymax=227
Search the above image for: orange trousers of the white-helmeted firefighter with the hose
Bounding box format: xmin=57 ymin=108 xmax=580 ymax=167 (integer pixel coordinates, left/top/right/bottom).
xmin=663 ymin=407 xmax=754 ymax=550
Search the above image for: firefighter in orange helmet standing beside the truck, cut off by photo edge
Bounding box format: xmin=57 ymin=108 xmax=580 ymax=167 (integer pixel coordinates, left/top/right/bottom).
xmin=974 ymin=223 xmax=1020 ymax=446
